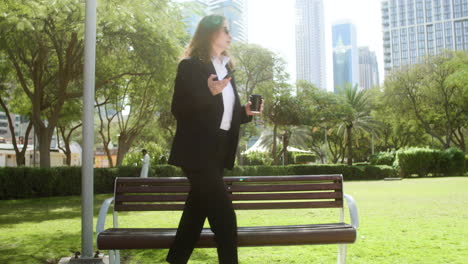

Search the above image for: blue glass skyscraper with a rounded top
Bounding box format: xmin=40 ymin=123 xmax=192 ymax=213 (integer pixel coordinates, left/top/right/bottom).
xmin=332 ymin=21 xmax=359 ymax=93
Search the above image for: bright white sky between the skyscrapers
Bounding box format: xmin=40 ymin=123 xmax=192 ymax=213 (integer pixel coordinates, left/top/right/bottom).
xmin=246 ymin=0 xmax=384 ymax=91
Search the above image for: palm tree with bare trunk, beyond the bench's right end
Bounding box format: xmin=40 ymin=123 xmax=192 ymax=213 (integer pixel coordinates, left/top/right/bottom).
xmin=338 ymin=83 xmax=377 ymax=165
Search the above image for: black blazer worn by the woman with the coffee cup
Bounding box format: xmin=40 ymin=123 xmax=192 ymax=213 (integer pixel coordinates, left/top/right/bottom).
xmin=169 ymin=57 xmax=252 ymax=169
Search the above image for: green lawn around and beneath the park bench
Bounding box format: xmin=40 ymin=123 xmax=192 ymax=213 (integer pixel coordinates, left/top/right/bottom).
xmin=0 ymin=177 xmax=468 ymax=264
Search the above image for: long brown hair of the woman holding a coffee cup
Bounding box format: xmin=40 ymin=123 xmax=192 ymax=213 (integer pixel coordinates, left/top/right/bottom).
xmin=185 ymin=15 xmax=232 ymax=63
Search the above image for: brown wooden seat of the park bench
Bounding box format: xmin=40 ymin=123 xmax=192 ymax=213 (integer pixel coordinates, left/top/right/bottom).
xmin=97 ymin=223 xmax=356 ymax=250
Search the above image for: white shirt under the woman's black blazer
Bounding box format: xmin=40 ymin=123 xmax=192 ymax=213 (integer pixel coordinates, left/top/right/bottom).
xmin=211 ymin=56 xmax=236 ymax=130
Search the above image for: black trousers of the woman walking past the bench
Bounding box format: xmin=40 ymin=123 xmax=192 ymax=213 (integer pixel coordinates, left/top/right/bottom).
xmin=166 ymin=130 xmax=238 ymax=264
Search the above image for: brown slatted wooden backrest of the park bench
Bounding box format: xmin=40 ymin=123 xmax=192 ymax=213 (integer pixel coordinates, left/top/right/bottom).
xmin=114 ymin=175 xmax=343 ymax=211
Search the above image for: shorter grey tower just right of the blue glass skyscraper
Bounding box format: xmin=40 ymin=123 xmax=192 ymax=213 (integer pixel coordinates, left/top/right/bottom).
xmin=359 ymin=47 xmax=380 ymax=89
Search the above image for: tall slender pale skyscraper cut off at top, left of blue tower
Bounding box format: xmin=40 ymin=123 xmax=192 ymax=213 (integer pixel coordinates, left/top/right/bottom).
xmin=296 ymin=0 xmax=326 ymax=89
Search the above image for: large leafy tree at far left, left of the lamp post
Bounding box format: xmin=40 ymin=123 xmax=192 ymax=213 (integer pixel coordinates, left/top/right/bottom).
xmin=0 ymin=0 xmax=83 ymax=167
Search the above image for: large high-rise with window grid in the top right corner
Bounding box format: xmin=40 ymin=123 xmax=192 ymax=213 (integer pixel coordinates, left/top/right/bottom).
xmin=381 ymin=0 xmax=468 ymax=73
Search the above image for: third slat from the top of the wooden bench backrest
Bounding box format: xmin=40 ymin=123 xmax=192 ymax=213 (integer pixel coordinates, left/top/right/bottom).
xmin=115 ymin=192 xmax=343 ymax=202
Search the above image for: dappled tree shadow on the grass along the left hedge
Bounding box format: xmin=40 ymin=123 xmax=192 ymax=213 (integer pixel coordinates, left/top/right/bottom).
xmin=0 ymin=194 xmax=112 ymax=225
